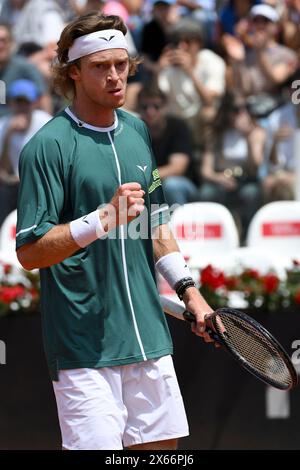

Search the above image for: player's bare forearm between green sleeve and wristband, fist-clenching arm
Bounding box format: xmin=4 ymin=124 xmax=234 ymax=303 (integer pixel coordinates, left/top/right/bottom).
xmin=17 ymin=224 xmax=80 ymax=270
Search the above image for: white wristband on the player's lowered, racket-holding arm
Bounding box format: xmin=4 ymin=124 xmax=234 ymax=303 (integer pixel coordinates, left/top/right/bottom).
xmin=155 ymin=251 xmax=192 ymax=288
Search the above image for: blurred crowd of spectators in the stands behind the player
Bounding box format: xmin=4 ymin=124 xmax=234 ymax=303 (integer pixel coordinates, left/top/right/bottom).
xmin=0 ymin=0 xmax=300 ymax=238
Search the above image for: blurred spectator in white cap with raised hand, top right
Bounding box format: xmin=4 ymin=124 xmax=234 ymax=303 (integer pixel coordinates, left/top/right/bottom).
xmin=226 ymin=5 xmax=298 ymax=177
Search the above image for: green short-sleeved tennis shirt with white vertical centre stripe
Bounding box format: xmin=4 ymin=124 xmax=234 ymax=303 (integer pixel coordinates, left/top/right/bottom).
xmin=17 ymin=108 xmax=172 ymax=380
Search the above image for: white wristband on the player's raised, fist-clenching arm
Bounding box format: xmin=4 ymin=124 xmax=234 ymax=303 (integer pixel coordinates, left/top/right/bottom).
xmin=70 ymin=209 xmax=106 ymax=248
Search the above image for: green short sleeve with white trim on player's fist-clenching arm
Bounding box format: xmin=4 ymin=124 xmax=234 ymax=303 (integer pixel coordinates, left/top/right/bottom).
xmin=16 ymin=136 xmax=64 ymax=249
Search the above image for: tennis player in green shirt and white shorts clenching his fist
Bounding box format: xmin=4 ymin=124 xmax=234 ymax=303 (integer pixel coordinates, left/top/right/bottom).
xmin=17 ymin=14 xmax=211 ymax=450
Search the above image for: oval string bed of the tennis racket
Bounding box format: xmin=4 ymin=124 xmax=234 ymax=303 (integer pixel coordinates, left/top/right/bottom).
xmin=214 ymin=314 xmax=292 ymax=386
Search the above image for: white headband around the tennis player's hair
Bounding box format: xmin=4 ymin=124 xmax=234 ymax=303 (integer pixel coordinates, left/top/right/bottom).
xmin=68 ymin=29 xmax=128 ymax=62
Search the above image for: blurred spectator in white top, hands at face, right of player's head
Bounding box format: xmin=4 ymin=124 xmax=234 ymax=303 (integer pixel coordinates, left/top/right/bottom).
xmin=158 ymin=18 xmax=226 ymax=147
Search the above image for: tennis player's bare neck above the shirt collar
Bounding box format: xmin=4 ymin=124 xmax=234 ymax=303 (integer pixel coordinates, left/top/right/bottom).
xmin=71 ymin=98 xmax=115 ymax=127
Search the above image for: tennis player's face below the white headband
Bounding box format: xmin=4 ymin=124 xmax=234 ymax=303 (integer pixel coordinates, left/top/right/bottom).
xmin=70 ymin=49 xmax=129 ymax=109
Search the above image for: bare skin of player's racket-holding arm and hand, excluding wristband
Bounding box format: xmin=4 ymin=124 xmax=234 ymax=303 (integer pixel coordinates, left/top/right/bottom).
xmin=152 ymin=224 xmax=213 ymax=342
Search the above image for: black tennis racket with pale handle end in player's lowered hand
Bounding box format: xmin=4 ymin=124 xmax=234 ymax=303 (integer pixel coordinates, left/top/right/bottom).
xmin=160 ymin=295 xmax=298 ymax=390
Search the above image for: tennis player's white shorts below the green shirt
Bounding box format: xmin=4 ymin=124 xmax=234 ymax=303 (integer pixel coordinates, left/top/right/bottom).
xmin=53 ymin=356 xmax=189 ymax=450
